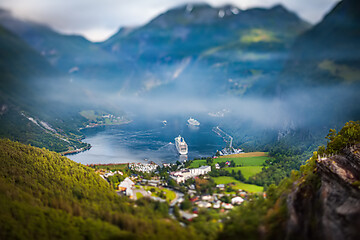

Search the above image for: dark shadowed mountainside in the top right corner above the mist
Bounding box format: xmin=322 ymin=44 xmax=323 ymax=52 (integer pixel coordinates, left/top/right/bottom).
xmin=282 ymin=0 xmax=360 ymax=89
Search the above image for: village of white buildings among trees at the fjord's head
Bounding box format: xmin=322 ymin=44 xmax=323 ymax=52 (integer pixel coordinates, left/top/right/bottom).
xmin=90 ymin=155 xmax=265 ymax=221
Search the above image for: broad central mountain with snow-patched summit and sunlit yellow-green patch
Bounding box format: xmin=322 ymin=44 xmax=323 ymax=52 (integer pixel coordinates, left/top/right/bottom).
xmin=101 ymin=4 xmax=310 ymax=95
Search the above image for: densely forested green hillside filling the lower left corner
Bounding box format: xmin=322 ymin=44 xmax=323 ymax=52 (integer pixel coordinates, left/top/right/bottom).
xmin=0 ymin=140 xmax=201 ymax=239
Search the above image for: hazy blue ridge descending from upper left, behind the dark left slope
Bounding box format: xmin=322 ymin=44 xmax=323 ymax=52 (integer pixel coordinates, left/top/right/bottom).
xmin=0 ymin=9 xmax=121 ymax=91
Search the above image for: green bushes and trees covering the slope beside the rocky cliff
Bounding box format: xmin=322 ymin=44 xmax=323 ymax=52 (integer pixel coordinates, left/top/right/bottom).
xmin=218 ymin=121 xmax=360 ymax=239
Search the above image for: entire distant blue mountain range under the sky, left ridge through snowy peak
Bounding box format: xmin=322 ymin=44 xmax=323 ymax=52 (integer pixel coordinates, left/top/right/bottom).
xmin=0 ymin=4 xmax=310 ymax=95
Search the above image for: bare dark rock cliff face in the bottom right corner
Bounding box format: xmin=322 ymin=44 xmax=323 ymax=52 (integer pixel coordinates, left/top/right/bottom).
xmin=286 ymin=144 xmax=360 ymax=240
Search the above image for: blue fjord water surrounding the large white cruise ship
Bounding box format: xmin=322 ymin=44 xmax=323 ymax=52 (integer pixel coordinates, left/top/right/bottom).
xmin=68 ymin=118 xmax=226 ymax=164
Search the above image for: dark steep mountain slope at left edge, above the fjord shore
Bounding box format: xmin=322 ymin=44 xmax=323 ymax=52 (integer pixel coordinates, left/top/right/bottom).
xmin=0 ymin=26 xmax=87 ymax=151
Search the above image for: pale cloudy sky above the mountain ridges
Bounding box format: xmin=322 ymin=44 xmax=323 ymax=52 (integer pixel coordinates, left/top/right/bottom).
xmin=0 ymin=0 xmax=339 ymax=41
